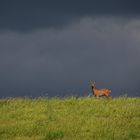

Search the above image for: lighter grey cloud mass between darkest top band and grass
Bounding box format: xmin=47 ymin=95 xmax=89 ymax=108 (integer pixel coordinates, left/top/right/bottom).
xmin=0 ymin=18 xmax=140 ymax=96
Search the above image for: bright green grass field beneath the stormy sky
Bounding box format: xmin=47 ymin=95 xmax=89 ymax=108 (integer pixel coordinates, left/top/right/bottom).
xmin=0 ymin=97 xmax=140 ymax=140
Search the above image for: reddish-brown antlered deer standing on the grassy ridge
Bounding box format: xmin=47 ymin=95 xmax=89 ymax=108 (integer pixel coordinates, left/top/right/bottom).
xmin=90 ymin=80 xmax=111 ymax=98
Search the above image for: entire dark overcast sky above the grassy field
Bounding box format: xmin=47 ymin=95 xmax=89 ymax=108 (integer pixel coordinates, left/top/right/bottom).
xmin=0 ymin=0 xmax=140 ymax=97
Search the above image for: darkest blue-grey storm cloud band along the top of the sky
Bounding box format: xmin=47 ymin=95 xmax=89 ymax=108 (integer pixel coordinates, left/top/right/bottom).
xmin=0 ymin=0 xmax=140 ymax=31
